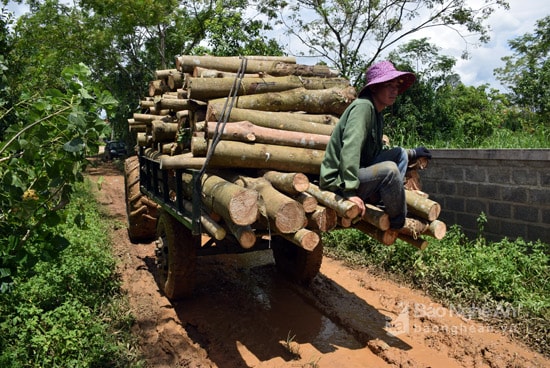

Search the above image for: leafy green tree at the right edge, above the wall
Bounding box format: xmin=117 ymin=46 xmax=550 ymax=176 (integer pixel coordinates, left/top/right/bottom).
xmin=494 ymin=16 xmax=550 ymax=126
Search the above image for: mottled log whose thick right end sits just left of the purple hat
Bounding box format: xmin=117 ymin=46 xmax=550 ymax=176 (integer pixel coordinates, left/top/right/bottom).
xmin=208 ymin=87 xmax=357 ymax=115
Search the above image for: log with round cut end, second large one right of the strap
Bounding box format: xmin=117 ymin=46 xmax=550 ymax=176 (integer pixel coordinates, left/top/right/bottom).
xmin=230 ymin=176 xmax=306 ymax=234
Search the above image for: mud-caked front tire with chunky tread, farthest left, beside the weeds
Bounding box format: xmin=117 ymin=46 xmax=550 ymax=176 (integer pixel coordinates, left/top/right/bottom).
xmin=124 ymin=156 xmax=159 ymax=243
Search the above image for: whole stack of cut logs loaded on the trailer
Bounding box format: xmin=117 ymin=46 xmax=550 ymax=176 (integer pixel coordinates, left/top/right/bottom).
xmin=128 ymin=56 xmax=446 ymax=250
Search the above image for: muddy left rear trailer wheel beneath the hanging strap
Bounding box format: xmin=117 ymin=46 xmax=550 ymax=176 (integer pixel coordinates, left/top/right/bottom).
xmin=156 ymin=212 xmax=196 ymax=300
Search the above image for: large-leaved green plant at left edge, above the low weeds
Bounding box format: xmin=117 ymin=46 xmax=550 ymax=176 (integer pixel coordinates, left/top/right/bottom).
xmin=0 ymin=64 xmax=116 ymax=292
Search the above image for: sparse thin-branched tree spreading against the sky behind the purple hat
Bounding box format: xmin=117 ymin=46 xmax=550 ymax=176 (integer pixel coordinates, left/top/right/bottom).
xmin=285 ymin=0 xmax=508 ymax=86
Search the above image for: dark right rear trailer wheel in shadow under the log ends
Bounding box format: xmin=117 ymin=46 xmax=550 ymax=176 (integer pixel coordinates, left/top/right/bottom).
xmin=271 ymin=236 xmax=323 ymax=284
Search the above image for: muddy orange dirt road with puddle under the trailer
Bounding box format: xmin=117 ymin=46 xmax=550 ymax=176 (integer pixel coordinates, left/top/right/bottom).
xmin=88 ymin=162 xmax=550 ymax=368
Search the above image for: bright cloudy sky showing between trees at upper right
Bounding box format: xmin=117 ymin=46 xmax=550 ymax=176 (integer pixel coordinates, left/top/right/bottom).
xmin=8 ymin=0 xmax=550 ymax=92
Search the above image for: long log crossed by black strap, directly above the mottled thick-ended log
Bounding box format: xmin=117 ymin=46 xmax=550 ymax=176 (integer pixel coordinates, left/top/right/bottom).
xmin=187 ymin=75 xmax=349 ymax=101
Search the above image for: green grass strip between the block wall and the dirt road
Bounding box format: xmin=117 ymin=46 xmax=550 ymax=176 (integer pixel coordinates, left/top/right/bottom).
xmin=323 ymin=226 xmax=550 ymax=355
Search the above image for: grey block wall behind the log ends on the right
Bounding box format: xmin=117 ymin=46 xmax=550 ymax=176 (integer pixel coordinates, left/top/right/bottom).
xmin=420 ymin=149 xmax=550 ymax=243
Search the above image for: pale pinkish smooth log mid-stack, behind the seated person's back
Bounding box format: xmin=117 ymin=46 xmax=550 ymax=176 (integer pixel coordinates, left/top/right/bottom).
xmin=207 ymin=121 xmax=330 ymax=150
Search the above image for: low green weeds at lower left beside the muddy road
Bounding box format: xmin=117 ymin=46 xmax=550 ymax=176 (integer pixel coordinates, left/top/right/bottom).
xmin=0 ymin=182 xmax=143 ymax=367
